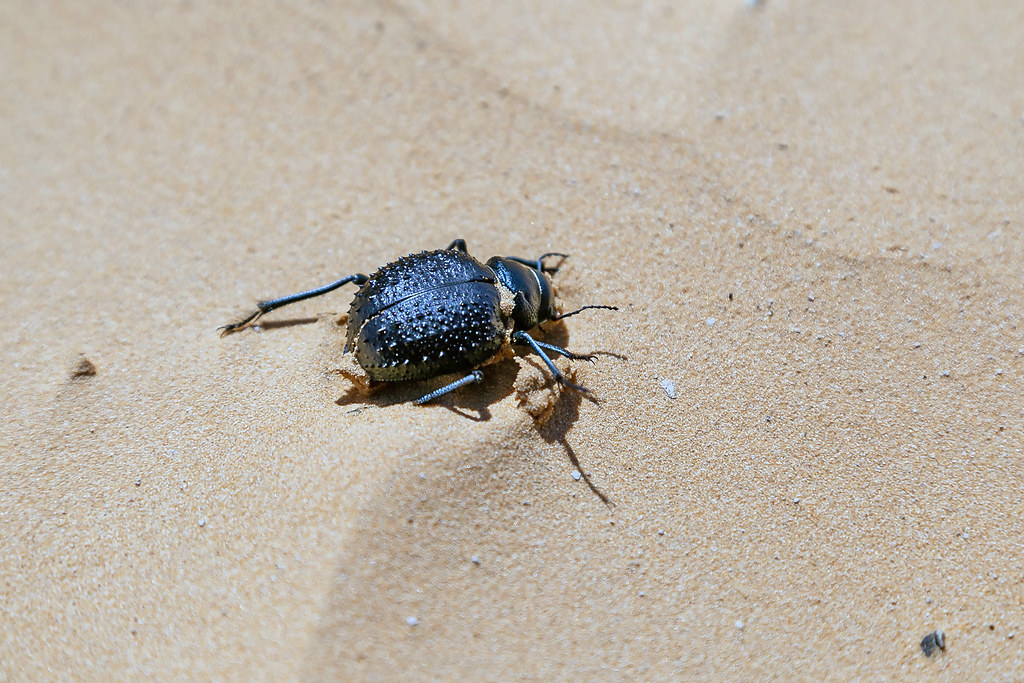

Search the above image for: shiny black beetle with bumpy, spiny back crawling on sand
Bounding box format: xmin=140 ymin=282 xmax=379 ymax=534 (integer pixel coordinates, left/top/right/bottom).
xmin=221 ymin=240 xmax=618 ymax=404
